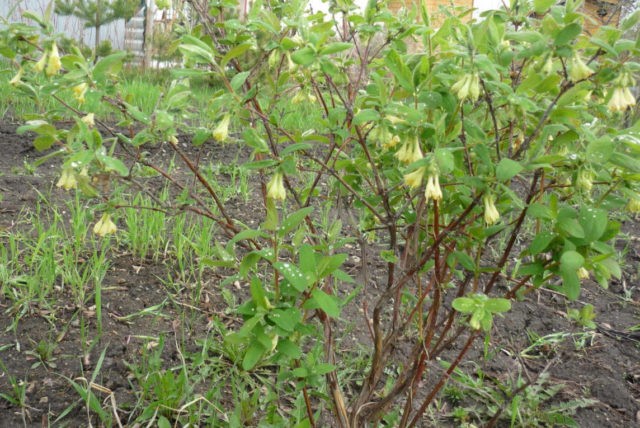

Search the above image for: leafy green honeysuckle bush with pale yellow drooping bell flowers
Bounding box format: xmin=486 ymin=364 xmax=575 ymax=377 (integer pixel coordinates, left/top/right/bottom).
xmin=0 ymin=0 xmax=640 ymax=426
